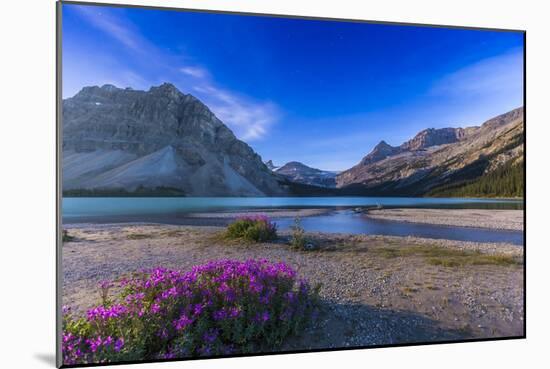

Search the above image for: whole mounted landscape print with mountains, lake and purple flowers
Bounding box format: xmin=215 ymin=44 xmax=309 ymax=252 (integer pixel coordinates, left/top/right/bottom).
xmin=57 ymin=2 xmax=525 ymax=367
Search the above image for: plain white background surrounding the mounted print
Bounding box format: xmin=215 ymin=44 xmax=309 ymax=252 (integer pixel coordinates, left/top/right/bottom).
xmin=0 ymin=0 xmax=550 ymax=369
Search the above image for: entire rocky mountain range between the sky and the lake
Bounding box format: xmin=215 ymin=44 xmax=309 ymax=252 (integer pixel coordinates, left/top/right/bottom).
xmin=62 ymin=83 xmax=524 ymax=196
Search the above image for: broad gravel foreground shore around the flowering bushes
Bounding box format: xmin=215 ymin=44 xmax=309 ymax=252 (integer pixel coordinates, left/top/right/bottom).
xmin=63 ymin=224 xmax=524 ymax=350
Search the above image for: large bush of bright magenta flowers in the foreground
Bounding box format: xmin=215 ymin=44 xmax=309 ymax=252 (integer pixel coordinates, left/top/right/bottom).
xmin=62 ymin=260 xmax=318 ymax=365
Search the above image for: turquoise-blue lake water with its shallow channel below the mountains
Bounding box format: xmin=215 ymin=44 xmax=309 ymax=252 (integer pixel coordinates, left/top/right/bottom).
xmin=62 ymin=197 xmax=523 ymax=245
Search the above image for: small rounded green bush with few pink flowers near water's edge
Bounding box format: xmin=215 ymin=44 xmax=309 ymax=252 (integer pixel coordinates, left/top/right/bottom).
xmin=225 ymin=215 xmax=277 ymax=242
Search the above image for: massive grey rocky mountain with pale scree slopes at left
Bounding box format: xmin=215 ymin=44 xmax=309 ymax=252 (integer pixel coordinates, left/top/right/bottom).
xmin=63 ymin=83 xmax=285 ymax=196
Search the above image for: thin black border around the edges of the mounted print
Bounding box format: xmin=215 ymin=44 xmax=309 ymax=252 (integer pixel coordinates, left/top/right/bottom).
xmin=55 ymin=0 xmax=527 ymax=368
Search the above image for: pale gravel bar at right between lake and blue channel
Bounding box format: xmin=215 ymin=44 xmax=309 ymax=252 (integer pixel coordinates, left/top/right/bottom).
xmin=365 ymin=209 xmax=523 ymax=231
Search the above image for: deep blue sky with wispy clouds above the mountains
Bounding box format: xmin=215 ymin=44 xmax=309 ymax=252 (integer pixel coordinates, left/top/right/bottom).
xmin=63 ymin=4 xmax=523 ymax=170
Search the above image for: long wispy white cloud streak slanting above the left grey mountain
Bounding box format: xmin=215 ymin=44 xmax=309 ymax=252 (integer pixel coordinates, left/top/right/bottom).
xmin=70 ymin=6 xmax=280 ymax=141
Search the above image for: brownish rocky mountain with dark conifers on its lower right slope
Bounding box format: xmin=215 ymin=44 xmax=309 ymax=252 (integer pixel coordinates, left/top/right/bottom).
xmin=336 ymin=108 xmax=524 ymax=197
